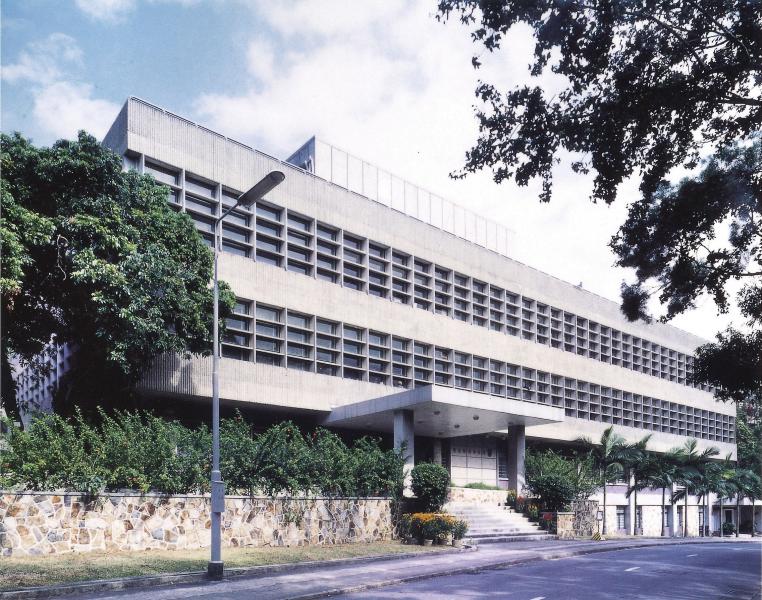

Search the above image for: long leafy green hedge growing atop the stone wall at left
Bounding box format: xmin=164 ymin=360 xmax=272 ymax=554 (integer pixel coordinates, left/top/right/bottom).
xmin=0 ymin=411 xmax=404 ymax=497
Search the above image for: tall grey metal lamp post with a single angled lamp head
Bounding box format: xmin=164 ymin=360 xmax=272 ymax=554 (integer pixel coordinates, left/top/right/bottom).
xmin=207 ymin=171 xmax=286 ymax=579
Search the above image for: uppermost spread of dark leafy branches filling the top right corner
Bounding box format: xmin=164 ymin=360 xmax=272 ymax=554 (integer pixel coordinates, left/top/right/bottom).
xmin=438 ymin=0 xmax=762 ymax=203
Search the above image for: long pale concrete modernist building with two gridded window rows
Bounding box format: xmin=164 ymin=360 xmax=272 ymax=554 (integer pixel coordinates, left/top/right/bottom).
xmin=98 ymin=98 xmax=736 ymax=536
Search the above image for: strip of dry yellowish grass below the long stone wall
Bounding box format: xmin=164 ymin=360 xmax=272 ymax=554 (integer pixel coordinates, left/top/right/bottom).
xmin=0 ymin=541 xmax=443 ymax=590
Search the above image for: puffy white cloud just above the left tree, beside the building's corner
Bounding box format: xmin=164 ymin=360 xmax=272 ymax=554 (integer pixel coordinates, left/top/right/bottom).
xmin=33 ymin=81 xmax=119 ymax=139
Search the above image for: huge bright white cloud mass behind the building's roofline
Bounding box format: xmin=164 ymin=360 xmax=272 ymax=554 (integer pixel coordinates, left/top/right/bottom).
xmin=195 ymin=0 xmax=723 ymax=337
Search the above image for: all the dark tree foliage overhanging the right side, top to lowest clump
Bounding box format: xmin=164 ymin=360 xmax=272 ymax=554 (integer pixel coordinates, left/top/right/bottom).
xmin=438 ymin=0 xmax=762 ymax=400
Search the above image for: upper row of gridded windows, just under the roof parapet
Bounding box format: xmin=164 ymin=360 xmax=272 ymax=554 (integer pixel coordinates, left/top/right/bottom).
xmin=145 ymin=161 xmax=713 ymax=391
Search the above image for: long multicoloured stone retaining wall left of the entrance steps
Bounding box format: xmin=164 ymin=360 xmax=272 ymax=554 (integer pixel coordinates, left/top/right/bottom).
xmin=0 ymin=492 xmax=393 ymax=556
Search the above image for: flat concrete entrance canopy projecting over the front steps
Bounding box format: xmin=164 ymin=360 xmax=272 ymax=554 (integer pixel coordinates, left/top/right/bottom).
xmin=323 ymin=385 xmax=564 ymax=438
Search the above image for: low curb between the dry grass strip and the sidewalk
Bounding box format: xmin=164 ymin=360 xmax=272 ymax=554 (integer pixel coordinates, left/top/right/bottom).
xmin=0 ymin=546 xmax=470 ymax=600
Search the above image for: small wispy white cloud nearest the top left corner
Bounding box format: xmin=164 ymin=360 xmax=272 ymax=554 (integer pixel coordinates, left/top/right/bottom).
xmin=1 ymin=33 xmax=82 ymax=84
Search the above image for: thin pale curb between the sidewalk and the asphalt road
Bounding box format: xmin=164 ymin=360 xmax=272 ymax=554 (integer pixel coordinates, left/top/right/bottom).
xmin=285 ymin=540 xmax=751 ymax=600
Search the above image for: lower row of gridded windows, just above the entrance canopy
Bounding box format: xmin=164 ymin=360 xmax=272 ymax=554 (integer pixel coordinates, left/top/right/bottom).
xmin=222 ymin=300 xmax=734 ymax=442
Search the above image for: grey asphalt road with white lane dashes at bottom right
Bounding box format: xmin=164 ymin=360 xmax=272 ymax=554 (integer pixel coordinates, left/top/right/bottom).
xmin=341 ymin=543 xmax=762 ymax=600
